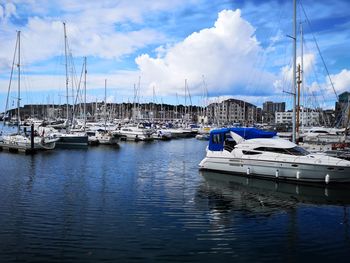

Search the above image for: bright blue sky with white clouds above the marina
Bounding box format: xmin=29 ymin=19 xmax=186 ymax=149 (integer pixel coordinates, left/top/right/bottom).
xmin=0 ymin=0 xmax=350 ymax=112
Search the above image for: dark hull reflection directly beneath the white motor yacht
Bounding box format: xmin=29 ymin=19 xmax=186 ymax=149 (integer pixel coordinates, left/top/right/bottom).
xmin=200 ymin=171 xmax=350 ymax=205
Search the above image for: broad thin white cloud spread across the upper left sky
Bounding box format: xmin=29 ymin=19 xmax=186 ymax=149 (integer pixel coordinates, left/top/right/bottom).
xmin=0 ymin=1 xmax=169 ymax=68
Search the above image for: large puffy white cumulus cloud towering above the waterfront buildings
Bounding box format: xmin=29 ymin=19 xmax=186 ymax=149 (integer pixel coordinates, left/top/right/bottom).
xmin=136 ymin=9 xmax=272 ymax=98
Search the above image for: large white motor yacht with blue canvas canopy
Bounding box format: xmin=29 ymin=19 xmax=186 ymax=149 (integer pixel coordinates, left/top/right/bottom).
xmin=199 ymin=128 xmax=350 ymax=183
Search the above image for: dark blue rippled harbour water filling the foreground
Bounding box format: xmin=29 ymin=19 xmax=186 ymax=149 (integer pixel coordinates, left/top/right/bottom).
xmin=0 ymin=133 xmax=350 ymax=262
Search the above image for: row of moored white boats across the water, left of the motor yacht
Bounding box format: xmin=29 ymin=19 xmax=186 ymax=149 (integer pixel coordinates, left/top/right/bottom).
xmin=0 ymin=120 xmax=202 ymax=152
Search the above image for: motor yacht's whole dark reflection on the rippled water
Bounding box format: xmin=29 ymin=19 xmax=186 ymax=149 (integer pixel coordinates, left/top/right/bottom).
xmin=200 ymin=171 xmax=350 ymax=212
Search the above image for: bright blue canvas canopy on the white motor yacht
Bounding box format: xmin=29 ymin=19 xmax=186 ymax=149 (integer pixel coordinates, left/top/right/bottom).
xmin=209 ymin=128 xmax=277 ymax=151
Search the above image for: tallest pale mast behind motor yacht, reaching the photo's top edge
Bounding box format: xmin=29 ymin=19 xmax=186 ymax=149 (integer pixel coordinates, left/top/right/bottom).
xmin=292 ymin=0 xmax=297 ymax=143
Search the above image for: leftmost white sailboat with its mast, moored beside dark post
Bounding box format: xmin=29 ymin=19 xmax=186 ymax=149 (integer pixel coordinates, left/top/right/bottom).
xmin=0 ymin=31 xmax=58 ymax=152
